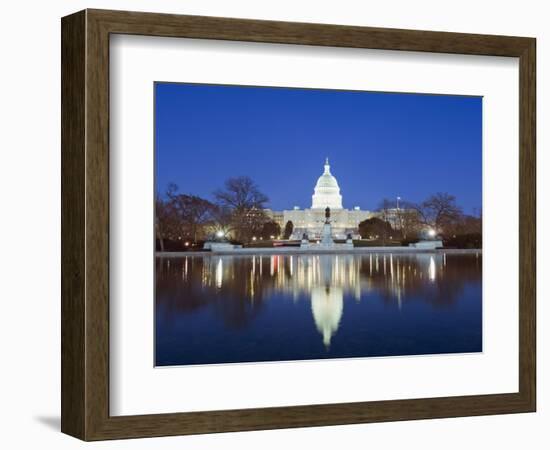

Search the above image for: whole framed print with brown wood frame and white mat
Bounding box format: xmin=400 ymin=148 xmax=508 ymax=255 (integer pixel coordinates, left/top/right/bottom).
xmin=62 ymin=10 xmax=536 ymax=440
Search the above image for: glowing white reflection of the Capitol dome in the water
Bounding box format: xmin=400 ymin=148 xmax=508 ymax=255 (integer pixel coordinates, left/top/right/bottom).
xmin=311 ymin=286 xmax=344 ymax=347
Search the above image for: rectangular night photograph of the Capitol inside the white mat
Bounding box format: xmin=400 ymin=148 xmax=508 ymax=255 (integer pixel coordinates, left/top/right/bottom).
xmin=151 ymin=81 xmax=483 ymax=367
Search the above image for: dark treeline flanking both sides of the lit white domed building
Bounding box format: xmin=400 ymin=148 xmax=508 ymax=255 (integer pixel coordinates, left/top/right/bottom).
xmin=155 ymin=176 xmax=482 ymax=251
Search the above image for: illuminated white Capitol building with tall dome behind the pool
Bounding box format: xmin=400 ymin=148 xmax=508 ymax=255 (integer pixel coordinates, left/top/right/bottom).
xmin=265 ymin=158 xmax=378 ymax=239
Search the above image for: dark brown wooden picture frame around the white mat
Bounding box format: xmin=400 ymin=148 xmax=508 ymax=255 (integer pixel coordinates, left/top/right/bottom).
xmin=61 ymin=10 xmax=536 ymax=440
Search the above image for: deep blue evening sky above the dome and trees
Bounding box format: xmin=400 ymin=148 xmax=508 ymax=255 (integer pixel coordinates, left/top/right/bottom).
xmin=155 ymin=83 xmax=482 ymax=213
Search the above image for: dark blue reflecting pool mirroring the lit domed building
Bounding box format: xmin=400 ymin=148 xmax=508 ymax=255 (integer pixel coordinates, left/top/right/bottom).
xmin=155 ymin=253 xmax=482 ymax=366
